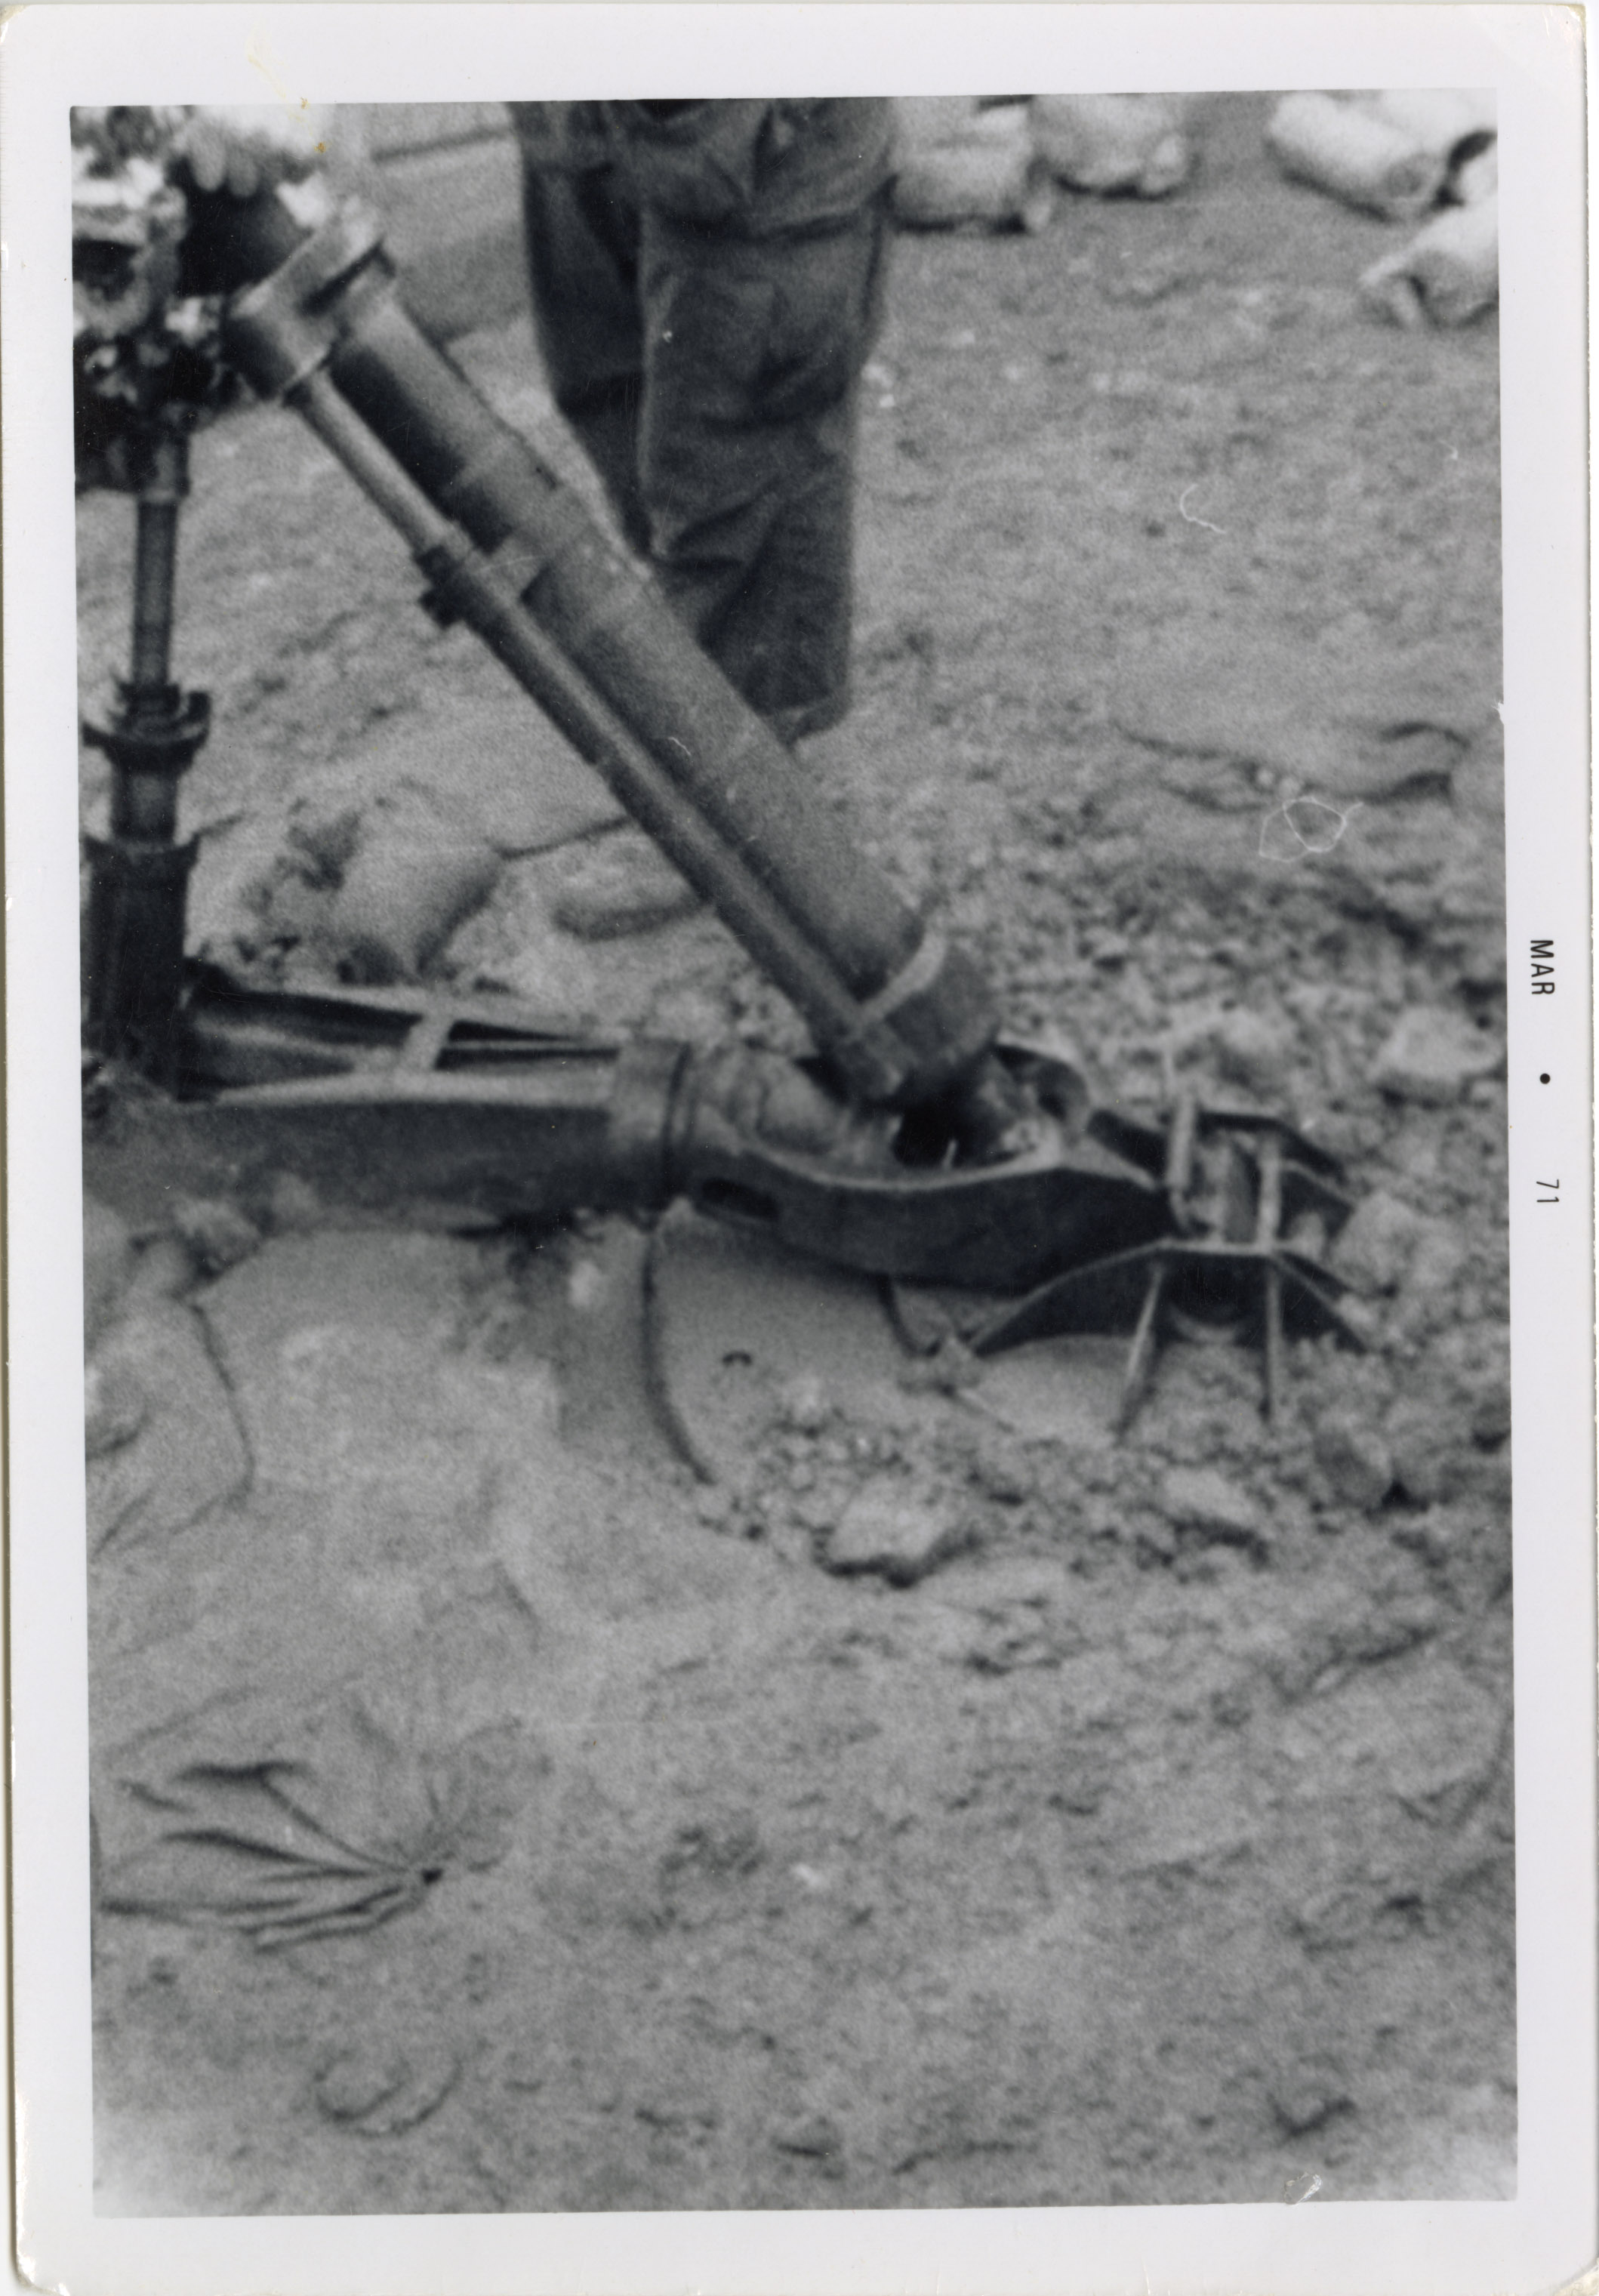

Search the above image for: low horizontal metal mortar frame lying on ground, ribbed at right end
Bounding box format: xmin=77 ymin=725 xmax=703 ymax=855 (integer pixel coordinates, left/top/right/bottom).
xmin=85 ymin=966 xmax=1360 ymax=1423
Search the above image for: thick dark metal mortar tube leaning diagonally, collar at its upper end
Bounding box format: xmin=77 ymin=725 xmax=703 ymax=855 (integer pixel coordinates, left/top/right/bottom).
xmin=227 ymin=218 xmax=997 ymax=1100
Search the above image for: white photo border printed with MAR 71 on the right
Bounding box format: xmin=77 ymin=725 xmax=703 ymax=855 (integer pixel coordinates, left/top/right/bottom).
xmin=0 ymin=0 xmax=1599 ymax=2296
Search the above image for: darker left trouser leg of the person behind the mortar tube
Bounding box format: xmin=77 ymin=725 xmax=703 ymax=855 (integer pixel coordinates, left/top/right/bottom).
xmin=522 ymin=161 xmax=650 ymax=553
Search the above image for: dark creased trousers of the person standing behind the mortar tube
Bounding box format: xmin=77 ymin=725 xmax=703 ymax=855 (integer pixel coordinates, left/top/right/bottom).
xmin=524 ymin=161 xmax=889 ymax=741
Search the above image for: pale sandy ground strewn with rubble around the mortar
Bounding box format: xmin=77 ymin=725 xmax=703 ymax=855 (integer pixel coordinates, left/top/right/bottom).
xmin=81 ymin=99 xmax=1516 ymax=2214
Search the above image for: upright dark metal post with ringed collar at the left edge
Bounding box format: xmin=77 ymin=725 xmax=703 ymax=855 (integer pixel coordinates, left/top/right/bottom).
xmin=83 ymin=427 xmax=211 ymax=1086
